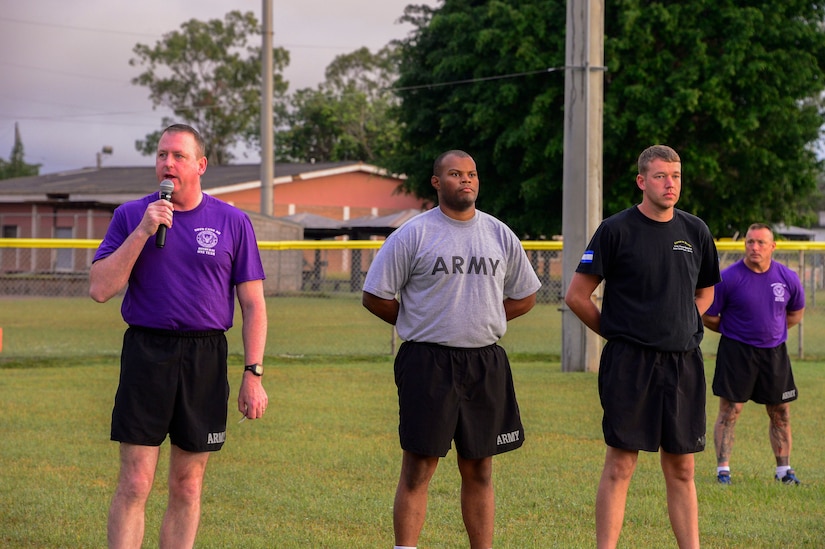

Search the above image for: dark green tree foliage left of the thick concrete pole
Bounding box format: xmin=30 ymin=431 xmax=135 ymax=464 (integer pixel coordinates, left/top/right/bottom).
xmin=389 ymin=0 xmax=566 ymax=238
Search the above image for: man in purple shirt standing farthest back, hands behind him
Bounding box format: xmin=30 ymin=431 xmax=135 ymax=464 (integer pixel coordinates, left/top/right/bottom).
xmin=702 ymin=223 xmax=805 ymax=485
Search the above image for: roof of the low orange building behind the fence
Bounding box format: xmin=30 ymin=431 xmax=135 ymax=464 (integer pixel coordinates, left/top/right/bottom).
xmin=0 ymin=162 xmax=396 ymax=204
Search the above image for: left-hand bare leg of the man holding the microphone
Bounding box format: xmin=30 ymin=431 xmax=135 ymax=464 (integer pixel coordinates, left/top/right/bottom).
xmin=107 ymin=443 xmax=159 ymax=549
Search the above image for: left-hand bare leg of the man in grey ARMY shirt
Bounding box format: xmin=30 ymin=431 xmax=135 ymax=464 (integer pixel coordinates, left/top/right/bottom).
xmin=392 ymin=450 xmax=438 ymax=547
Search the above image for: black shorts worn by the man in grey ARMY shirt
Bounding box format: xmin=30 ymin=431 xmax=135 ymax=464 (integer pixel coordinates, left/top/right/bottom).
xmin=395 ymin=341 xmax=524 ymax=459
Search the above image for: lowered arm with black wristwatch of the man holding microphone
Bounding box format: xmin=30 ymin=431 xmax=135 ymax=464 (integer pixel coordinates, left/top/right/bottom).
xmin=236 ymin=280 xmax=269 ymax=419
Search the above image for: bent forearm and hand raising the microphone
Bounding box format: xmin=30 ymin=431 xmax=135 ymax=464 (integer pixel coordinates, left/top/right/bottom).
xmin=89 ymin=200 xmax=172 ymax=303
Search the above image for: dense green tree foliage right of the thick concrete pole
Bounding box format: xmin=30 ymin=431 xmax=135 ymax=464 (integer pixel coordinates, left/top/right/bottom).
xmin=605 ymin=0 xmax=825 ymax=236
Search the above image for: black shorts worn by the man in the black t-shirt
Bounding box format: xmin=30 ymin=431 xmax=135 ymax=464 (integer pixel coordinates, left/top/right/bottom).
xmin=599 ymin=340 xmax=706 ymax=454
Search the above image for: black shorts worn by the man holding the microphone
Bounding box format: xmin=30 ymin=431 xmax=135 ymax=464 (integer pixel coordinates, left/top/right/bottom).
xmin=111 ymin=326 xmax=229 ymax=452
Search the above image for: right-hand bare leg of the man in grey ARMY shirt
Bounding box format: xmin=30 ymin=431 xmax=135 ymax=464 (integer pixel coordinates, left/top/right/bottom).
xmin=458 ymin=456 xmax=496 ymax=549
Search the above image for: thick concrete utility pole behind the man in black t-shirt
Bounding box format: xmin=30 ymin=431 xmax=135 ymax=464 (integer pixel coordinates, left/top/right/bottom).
xmin=561 ymin=0 xmax=605 ymax=372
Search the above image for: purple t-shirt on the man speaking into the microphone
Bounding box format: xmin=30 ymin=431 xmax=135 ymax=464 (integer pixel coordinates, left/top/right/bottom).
xmin=94 ymin=193 xmax=264 ymax=331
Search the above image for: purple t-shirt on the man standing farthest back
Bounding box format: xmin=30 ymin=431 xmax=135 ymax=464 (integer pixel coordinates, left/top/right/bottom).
xmin=705 ymin=259 xmax=805 ymax=349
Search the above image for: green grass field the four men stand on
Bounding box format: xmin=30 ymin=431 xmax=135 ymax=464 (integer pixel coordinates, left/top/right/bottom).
xmin=0 ymin=298 xmax=825 ymax=549
